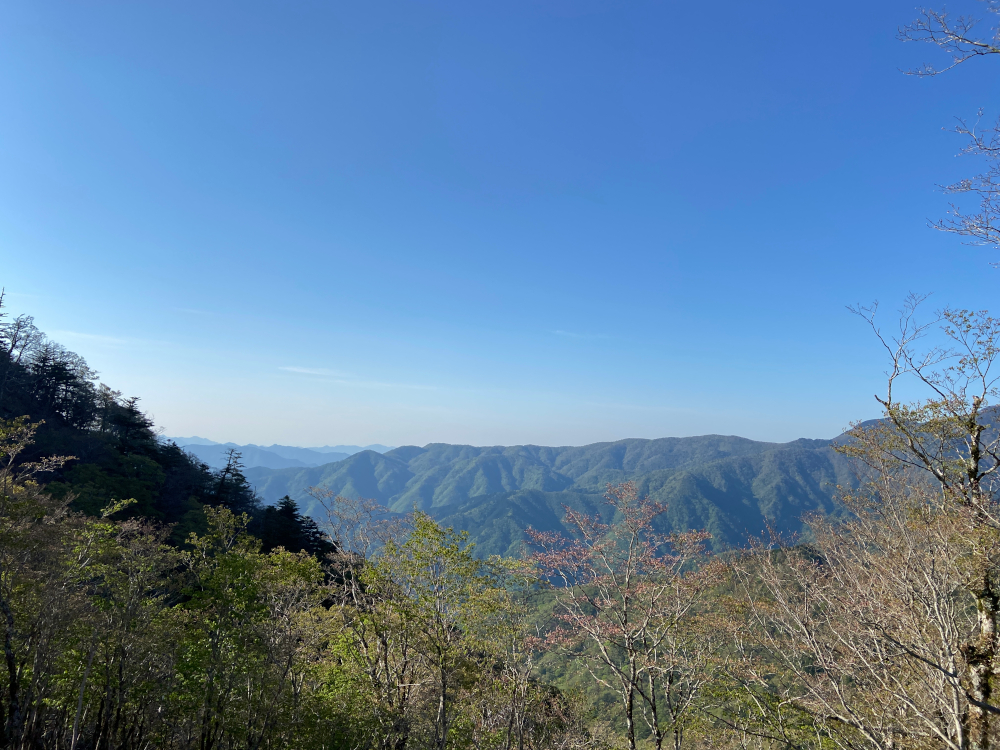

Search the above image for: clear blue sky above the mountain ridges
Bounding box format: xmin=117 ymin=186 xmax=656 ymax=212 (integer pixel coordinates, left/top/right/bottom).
xmin=0 ymin=0 xmax=1000 ymax=445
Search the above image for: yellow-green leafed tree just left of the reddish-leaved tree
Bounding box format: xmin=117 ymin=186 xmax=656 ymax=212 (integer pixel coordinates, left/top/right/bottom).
xmin=320 ymin=488 xmax=576 ymax=750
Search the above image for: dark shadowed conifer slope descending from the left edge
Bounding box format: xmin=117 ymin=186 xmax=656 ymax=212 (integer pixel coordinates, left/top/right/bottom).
xmin=0 ymin=302 xmax=326 ymax=552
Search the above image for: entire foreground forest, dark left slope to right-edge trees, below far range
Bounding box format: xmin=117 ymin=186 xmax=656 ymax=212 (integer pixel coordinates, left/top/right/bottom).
xmin=0 ymin=290 xmax=1000 ymax=750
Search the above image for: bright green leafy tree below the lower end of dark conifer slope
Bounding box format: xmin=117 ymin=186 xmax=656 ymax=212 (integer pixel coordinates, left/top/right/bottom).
xmin=175 ymin=508 xmax=323 ymax=748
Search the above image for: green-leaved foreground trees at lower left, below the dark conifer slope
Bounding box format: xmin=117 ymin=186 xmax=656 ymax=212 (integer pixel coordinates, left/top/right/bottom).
xmin=0 ymin=419 xmax=608 ymax=750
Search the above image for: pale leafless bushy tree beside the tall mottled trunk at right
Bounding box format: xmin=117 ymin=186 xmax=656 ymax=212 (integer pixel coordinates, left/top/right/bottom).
xmin=738 ymin=482 xmax=996 ymax=750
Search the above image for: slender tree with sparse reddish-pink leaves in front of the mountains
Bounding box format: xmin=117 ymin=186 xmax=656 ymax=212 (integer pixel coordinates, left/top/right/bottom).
xmin=528 ymin=482 xmax=721 ymax=750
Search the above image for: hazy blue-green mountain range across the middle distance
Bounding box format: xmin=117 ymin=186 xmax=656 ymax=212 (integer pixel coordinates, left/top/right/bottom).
xmin=246 ymin=435 xmax=854 ymax=554
